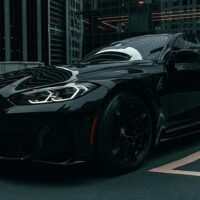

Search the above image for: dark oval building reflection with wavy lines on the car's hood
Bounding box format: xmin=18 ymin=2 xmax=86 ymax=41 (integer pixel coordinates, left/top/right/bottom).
xmin=0 ymin=67 xmax=75 ymax=90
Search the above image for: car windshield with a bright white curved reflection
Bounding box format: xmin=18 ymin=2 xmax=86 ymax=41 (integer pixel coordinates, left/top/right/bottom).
xmin=81 ymin=34 xmax=170 ymax=63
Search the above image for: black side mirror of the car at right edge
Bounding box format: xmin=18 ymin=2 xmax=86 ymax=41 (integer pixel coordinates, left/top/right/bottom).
xmin=170 ymin=49 xmax=200 ymax=63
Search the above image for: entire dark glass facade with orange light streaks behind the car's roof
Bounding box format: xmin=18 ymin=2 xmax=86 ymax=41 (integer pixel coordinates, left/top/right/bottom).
xmin=84 ymin=0 xmax=200 ymax=54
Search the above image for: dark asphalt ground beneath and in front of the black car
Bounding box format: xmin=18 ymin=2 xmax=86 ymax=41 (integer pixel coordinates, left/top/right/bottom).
xmin=0 ymin=136 xmax=200 ymax=200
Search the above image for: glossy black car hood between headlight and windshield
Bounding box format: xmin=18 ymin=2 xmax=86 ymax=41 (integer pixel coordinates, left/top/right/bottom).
xmin=0 ymin=62 xmax=152 ymax=96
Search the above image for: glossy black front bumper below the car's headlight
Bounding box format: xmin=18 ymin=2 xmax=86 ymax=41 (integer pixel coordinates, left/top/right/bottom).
xmin=0 ymin=87 xmax=107 ymax=163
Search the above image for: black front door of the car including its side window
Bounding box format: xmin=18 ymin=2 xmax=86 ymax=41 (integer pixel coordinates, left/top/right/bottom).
xmin=158 ymin=35 xmax=200 ymax=136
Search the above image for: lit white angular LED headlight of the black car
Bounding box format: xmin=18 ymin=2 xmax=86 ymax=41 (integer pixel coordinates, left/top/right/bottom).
xmin=10 ymin=83 xmax=97 ymax=105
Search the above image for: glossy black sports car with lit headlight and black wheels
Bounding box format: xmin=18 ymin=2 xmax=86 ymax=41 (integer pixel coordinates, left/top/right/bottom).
xmin=0 ymin=33 xmax=200 ymax=172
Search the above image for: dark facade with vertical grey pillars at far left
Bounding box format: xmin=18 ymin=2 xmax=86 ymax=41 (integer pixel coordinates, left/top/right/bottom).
xmin=0 ymin=0 xmax=48 ymax=63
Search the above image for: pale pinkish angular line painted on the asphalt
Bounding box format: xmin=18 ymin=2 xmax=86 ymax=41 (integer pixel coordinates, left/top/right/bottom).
xmin=149 ymin=151 xmax=200 ymax=176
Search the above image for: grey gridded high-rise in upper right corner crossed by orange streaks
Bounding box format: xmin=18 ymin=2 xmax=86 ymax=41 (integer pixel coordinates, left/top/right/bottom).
xmin=152 ymin=0 xmax=200 ymax=34
